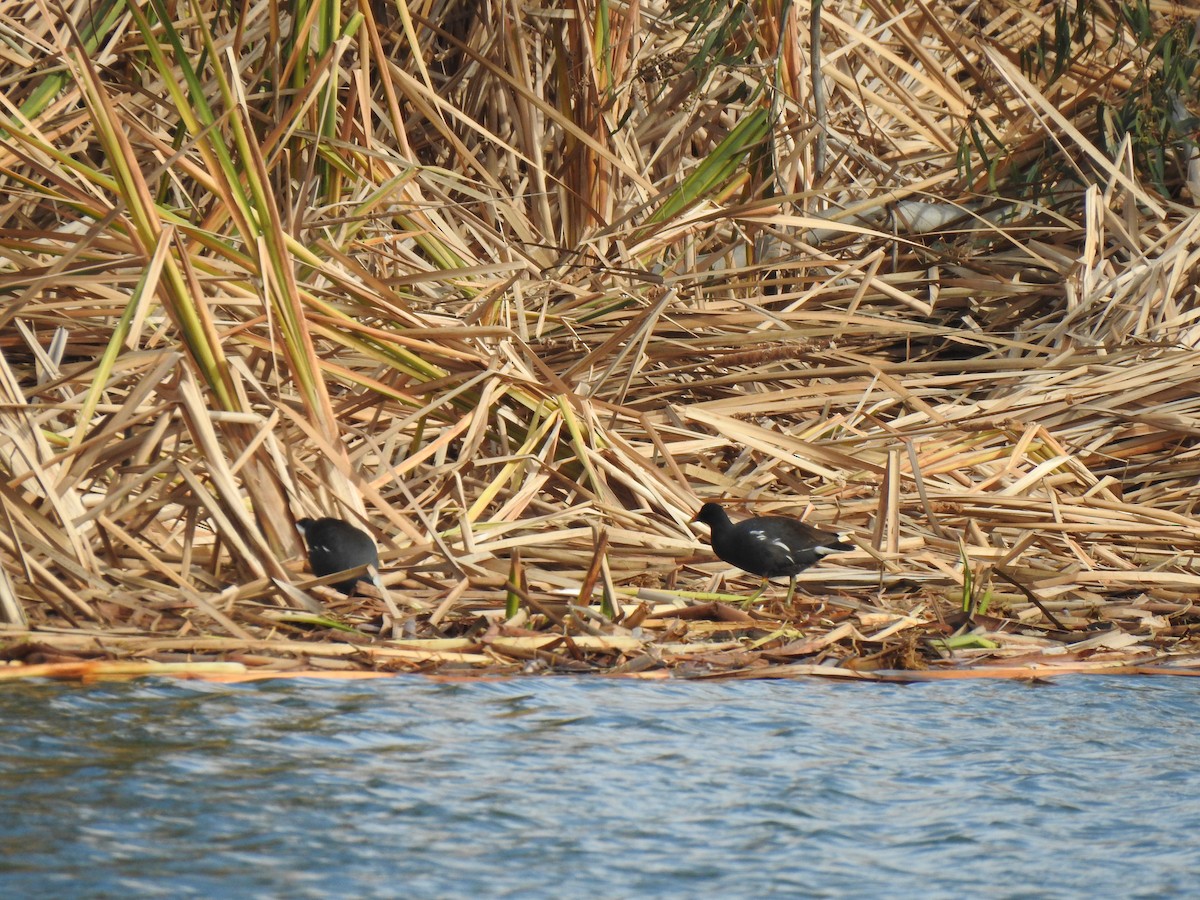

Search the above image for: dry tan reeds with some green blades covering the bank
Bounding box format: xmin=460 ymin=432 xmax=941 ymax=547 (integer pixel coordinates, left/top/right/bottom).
xmin=0 ymin=0 xmax=1200 ymax=680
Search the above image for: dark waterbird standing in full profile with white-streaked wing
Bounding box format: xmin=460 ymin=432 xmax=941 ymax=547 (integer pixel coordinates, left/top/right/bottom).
xmin=696 ymin=503 xmax=854 ymax=604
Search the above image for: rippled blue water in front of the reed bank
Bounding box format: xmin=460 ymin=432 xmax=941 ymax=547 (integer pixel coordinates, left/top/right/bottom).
xmin=0 ymin=677 xmax=1200 ymax=898
